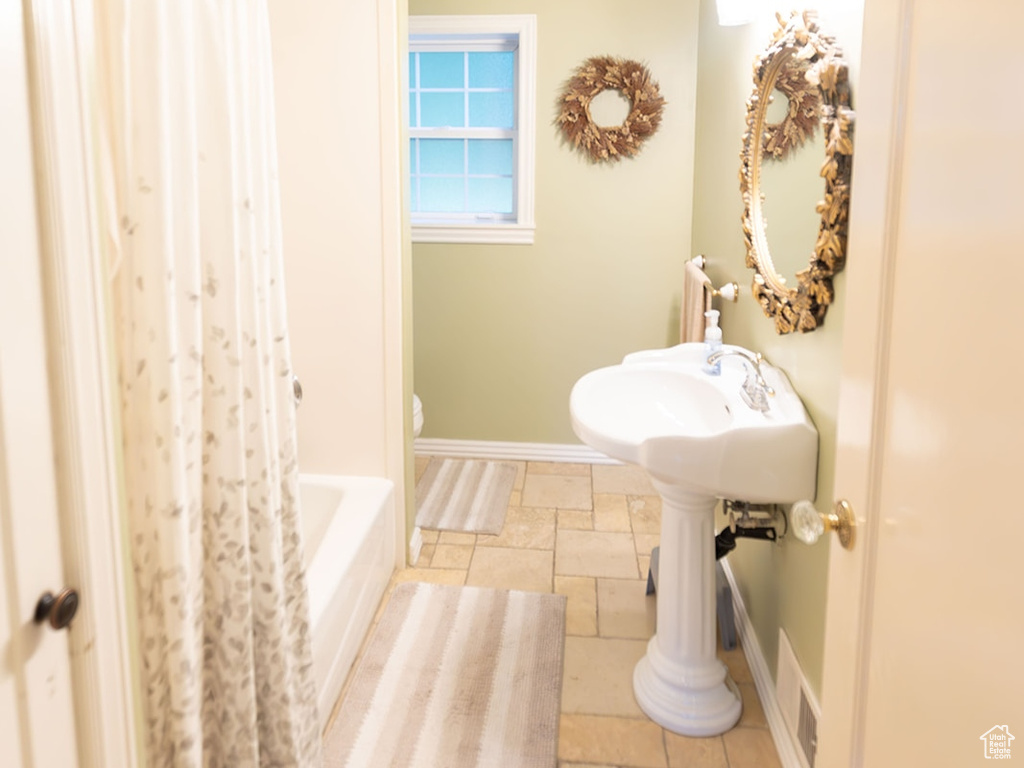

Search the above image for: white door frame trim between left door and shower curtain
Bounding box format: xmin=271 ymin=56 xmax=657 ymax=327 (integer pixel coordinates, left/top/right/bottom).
xmin=26 ymin=0 xmax=140 ymax=768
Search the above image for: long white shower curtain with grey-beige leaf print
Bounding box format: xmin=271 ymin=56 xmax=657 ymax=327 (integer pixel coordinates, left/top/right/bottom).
xmin=94 ymin=0 xmax=322 ymax=768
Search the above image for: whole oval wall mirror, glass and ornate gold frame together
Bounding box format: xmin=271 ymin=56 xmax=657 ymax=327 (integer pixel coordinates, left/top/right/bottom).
xmin=740 ymin=11 xmax=853 ymax=334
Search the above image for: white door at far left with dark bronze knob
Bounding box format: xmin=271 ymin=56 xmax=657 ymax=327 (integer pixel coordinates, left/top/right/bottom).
xmin=0 ymin=2 xmax=78 ymax=768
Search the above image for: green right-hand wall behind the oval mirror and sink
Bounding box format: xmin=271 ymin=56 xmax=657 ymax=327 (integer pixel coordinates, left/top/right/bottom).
xmin=693 ymin=0 xmax=863 ymax=693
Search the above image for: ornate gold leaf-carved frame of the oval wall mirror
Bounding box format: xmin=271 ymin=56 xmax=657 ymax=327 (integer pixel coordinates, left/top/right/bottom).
xmin=739 ymin=11 xmax=853 ymax=334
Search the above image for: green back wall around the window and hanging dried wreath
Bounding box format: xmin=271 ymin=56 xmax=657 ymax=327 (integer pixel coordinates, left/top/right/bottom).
xmin=409 ymin=0 xmax=700 ymax=443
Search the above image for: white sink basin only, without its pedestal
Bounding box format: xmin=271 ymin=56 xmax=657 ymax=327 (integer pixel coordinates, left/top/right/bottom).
xmin=569 ymin=344 xmax=818 ymax=504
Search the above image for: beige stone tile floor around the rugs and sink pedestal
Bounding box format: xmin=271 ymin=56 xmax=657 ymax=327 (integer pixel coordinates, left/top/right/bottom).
xmin=378 ymin=457 xmax=780 ymax=768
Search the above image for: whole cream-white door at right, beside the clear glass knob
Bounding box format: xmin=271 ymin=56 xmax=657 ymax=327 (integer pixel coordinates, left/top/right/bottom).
xmin=817 ymin=0 xmax=1024 ymax=768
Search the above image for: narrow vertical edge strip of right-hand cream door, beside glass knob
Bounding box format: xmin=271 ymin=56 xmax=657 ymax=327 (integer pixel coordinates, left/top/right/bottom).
xmin=816 ymin=0 xmax=910 ymax=767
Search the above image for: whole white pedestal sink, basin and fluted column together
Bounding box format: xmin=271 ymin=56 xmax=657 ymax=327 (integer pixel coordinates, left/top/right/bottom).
xmin=569 ymin=344 xmax=818 ymax=736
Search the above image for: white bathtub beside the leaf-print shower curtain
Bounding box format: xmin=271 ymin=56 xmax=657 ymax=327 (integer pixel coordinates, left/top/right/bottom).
xmin=299 ymin=474 xmax=395 ymax=728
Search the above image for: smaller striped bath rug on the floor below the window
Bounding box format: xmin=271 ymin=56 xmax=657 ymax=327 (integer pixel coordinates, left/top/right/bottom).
xmin=416 ymin=457 xmax=516 ymax=534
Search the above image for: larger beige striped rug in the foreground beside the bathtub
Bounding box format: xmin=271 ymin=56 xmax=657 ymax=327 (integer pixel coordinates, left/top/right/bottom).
xmin=325 ymin=584 xmax=565 ymax=768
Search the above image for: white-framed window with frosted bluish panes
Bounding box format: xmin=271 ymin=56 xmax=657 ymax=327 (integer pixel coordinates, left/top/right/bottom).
xmin=409 ymin=15 xmax=537 ymax=244
